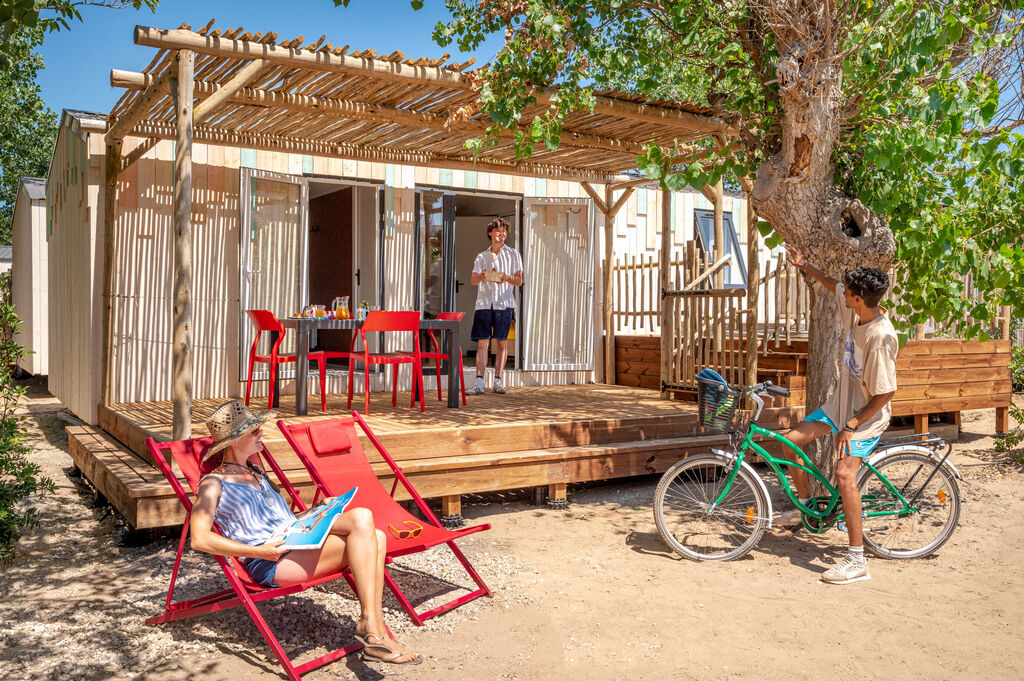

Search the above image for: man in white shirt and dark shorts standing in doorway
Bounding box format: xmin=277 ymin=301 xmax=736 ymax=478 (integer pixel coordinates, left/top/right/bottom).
xmin=469 ymin=217 xmax=522 ymax=395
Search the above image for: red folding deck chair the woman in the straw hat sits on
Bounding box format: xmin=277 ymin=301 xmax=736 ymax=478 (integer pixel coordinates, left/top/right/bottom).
xmin=145 ymin=437 xmax=362 ymax=681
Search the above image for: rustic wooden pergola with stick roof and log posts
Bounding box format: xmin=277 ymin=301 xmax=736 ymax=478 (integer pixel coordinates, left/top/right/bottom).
xmin=102 ymin=22 xmax=757 ymax=439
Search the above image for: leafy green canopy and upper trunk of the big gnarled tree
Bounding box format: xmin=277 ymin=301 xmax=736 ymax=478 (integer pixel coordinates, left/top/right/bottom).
xmin=423 ymin=0 xmax=1024 ymax=337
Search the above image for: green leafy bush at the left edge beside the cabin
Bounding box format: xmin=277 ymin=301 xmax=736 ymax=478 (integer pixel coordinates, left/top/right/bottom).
xmin=0 ymin=272 xmax=54 ymax=563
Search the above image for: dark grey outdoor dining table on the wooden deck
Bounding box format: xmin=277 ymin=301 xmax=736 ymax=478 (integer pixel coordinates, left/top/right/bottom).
xmin=270 ymin=317 xmax=462 ymax=416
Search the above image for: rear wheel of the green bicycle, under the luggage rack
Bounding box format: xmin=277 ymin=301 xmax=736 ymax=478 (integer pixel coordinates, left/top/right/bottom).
xmin=859 ymin=452 xmax=961 ymax=558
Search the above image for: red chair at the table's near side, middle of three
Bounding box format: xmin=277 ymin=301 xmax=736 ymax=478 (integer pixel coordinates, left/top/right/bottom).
xmin=348 ymin=310 xmax=427 ymax=414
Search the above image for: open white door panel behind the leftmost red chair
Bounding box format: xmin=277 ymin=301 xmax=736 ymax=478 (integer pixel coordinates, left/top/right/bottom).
xmin=239 ymin=168 xmax=308 ymax=381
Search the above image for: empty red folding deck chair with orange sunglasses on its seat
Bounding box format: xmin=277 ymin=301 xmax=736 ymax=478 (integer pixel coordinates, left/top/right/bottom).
xmin=278 ymin=412 xmax=490 ymax=626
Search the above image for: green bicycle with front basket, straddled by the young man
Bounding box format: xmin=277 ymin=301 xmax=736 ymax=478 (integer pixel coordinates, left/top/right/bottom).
xmin=654 ymin=370 xmax=963 ymax=560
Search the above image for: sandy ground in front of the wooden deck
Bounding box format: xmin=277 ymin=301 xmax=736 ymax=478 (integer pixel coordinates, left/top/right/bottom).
xmin=0 ymin=376 xmax=1024 ymax=681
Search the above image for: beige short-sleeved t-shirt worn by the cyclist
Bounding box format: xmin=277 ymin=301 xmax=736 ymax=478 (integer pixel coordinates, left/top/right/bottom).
xmin=821 ymin=284 xmax=899 ymax=439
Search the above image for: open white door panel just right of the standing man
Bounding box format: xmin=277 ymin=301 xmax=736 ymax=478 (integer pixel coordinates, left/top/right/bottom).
xmin=521 ymin=199 xmax=594 ymax=371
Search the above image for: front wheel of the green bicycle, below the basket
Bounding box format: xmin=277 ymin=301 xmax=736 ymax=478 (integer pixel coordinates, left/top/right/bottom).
xmin=654 ymin=454 xmax=768 ymax=560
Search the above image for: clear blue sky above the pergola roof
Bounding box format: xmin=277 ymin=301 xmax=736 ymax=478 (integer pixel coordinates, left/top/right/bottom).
xmin=38 ymin=0 xmax=501 ymax=113
